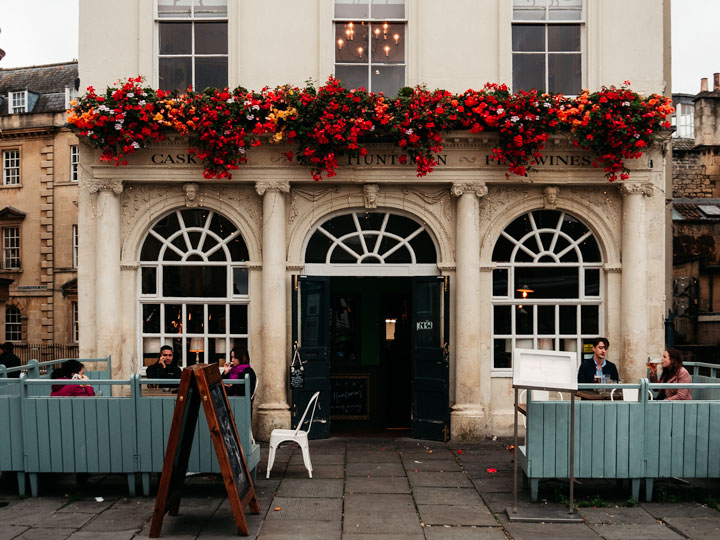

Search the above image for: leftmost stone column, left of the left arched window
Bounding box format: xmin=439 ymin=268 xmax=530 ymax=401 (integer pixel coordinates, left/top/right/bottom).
xmin=89 ymin=180 xmax=123 ymax=375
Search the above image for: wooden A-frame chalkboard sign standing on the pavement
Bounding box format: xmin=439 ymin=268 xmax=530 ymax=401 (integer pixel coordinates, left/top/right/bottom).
xmin=150 ymin=364 xmax=260 ymax=538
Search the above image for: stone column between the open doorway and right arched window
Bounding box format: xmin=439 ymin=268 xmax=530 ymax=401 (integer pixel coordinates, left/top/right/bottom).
xmin=450 ymin=183 xmax=488 ymax=440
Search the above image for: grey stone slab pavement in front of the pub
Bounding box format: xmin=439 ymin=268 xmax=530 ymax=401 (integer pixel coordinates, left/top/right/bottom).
xmin=0 ymin=437 xmax=720 ymax=540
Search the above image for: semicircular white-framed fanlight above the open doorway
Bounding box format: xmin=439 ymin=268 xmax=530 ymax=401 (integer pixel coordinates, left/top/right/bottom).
xmin=305 ymin=211 xmax=437 ymax=275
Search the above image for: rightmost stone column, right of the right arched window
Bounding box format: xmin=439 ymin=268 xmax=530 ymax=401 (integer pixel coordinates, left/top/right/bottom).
xmin=610 ymin=182 xmax=653 ymax=382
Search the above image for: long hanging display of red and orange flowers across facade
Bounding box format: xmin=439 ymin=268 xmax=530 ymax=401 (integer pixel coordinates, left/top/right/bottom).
xmin=68 ymin=77 xmax=673 ymax=182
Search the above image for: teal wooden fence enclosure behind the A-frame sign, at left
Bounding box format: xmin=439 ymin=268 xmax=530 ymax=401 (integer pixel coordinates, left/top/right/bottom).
xmin=0 ymin=357 xmax=260 ymax=497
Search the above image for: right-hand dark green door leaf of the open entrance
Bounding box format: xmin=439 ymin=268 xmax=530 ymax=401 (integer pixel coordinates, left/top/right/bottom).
xmin=411 ymin=276 xmax=450 ymax=441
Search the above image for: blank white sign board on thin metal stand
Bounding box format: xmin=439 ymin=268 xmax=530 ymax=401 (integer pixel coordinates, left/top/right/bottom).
xmin=513 ymin=349 xmax=578 ymax=390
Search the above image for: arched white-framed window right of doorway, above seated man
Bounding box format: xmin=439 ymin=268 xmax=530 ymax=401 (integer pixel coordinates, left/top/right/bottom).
xmin=492 ymin=210 xmax=604 ymax=369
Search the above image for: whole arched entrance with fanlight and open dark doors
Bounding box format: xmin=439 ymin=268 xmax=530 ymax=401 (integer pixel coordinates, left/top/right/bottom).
xmin=293 ymin=210 xmax=449 ymax=439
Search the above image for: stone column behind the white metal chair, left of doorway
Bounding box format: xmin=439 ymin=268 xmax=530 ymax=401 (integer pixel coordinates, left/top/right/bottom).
xmin=255 ymin=181 xmax=290 ymax=441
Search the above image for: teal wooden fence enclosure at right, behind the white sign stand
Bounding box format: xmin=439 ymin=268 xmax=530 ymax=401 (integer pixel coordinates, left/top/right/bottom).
xmin=518 ymin=363 xmax=720 ymax=501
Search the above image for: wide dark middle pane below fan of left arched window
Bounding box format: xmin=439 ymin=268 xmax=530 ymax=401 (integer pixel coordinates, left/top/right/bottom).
xmin=163 ymin=266 xmax=227 ymax=297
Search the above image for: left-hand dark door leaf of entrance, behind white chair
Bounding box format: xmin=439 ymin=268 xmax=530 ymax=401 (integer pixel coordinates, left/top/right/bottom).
xmin=292 ymin=276 xmax=330 ymax=439
